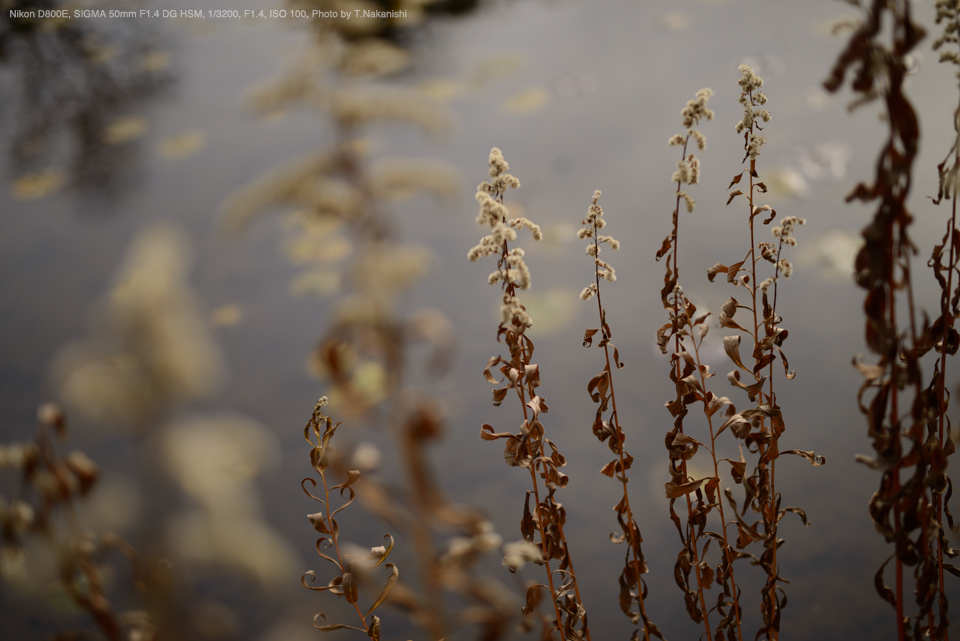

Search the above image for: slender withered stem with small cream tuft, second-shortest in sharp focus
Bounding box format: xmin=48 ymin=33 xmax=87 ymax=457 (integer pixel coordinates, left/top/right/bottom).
xmin=577 ymin=190 xmax=663 ymax=641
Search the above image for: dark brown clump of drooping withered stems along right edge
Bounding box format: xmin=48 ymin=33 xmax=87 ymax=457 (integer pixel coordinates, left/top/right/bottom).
xmin=824 ymin=0 xmax=960 ymax=639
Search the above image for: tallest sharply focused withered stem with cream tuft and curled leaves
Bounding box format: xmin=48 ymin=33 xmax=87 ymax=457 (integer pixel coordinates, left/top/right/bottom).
xmin=707 ymin=65 xmax=825 ymax=639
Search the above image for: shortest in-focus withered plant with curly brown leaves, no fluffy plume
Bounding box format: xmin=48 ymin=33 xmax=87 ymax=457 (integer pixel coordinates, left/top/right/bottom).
xmin=300 ymin=396 xmax=400 ymax=639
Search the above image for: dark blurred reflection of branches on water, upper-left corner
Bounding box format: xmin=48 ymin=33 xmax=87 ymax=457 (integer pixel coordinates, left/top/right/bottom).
xmin=0 ymin=1 xmax=174 ymax=200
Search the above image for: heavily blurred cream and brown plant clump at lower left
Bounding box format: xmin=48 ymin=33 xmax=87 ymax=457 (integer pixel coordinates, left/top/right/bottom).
xmin=0 ymin=221 xmax=295 ymax=641
